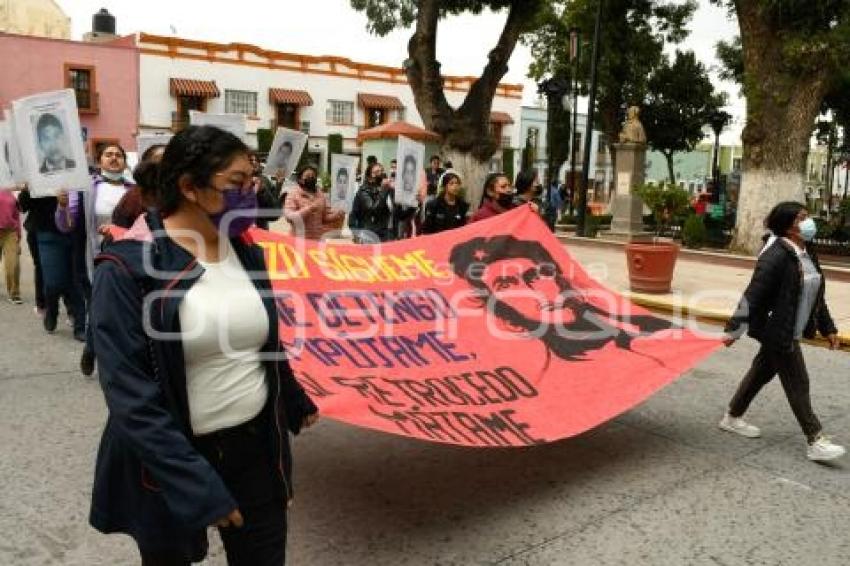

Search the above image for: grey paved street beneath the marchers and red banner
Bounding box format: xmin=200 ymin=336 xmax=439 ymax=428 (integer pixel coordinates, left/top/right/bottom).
xmin=0 ymin=237 xmax=850 ymax=566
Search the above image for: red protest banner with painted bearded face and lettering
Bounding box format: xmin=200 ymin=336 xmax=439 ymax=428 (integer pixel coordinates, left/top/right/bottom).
xmin=243 ymin=207 xmax=720 ymax=447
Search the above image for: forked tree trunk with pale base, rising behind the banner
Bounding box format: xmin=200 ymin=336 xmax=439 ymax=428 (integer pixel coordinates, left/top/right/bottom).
xmin=405 ymin=0 xmax=534 ymax=210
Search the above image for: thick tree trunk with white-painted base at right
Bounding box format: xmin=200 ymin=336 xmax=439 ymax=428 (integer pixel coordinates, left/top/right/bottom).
xmin=732 ymin=0 xmax=828 ymax=253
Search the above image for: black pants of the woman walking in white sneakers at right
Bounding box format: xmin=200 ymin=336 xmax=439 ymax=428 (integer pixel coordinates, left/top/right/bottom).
xmin=729 ymin=341 xmax=822 ymax=442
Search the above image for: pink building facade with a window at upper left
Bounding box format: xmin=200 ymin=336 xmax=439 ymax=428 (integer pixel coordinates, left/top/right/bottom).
xmin=0 ymin=33 xmax=139 ymax=154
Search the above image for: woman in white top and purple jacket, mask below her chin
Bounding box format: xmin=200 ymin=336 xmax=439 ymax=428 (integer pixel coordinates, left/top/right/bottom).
xmin=55 ymin=144 xmax=134 ymax=376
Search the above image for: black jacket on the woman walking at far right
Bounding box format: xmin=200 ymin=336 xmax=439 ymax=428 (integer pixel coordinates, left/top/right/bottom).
xmin=726 ymin=238 xmax=837 ymax=351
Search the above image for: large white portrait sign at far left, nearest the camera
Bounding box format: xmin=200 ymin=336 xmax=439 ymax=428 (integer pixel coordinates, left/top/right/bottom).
xmin=12 ymin=89 xmax=91 ymax=197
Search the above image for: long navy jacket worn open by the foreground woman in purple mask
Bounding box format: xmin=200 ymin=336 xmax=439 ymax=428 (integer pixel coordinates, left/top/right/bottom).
xmin=89 ymin=211 xmax=316 ymax=548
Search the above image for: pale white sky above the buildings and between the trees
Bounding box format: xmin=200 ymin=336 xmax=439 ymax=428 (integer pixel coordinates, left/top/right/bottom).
xmin=55 ymin=0 xmax=744 ymax=141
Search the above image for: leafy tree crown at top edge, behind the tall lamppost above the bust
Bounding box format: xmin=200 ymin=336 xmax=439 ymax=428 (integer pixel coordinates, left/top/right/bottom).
xmin=522 ymin=0 xmax=696 ymax=142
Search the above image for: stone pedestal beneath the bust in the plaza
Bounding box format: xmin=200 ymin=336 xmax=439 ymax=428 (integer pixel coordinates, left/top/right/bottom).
xmin=610 ymin=143 xmax=648 ymax=240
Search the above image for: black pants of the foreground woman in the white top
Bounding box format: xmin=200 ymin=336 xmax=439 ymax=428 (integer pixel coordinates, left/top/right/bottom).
xmin=140 ymin=411 xmax=286 ymax=566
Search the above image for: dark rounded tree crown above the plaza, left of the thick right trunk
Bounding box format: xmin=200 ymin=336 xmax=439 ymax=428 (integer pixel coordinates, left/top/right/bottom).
xmin=641 ymin=50 xmax=725 ymax=182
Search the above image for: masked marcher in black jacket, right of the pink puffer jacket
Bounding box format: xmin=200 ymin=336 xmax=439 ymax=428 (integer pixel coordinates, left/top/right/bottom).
xmin=348 ymin=162 xmax=395 ymax=243
